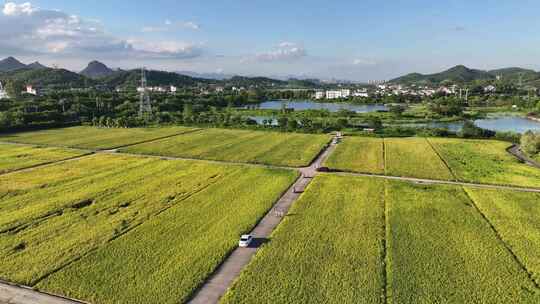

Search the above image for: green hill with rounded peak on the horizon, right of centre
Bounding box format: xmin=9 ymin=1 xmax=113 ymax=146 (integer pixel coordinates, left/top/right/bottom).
xmin=390 ymin=65 xmax=496 ymax=84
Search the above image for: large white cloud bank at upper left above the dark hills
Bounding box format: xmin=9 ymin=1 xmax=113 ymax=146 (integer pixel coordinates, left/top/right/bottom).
xmin=0 ymin=2 xmax=202 ymax=59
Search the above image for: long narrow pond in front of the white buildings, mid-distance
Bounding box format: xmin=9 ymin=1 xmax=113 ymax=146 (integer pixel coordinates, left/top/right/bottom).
xmin=250 ymin=100 xmax=388 ymax=113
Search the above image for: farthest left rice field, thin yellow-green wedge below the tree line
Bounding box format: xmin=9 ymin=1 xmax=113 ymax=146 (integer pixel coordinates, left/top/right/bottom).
xmin=0 ymin=126 xmax=197 ymax=150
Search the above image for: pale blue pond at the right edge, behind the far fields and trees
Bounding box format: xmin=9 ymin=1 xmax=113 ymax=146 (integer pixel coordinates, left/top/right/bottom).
xmin=402 ymin=116 xmax=540 ymax=133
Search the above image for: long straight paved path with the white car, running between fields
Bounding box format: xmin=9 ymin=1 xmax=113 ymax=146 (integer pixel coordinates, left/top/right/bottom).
xmin=189 ymin=141 xmax=335 ymax=304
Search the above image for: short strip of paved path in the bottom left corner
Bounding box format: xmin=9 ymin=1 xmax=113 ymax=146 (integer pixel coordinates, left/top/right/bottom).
xmin=0 ymin=281 xmax=84 ymax=304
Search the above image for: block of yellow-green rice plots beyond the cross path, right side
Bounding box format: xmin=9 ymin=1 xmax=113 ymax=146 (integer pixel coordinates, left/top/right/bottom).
xmin=326 ymin=137 xmax=540 ymax=188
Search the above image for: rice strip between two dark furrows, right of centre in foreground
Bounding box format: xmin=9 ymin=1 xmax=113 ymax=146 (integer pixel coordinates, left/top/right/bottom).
xmin=386 ymin=182 xmax=540 ymax=303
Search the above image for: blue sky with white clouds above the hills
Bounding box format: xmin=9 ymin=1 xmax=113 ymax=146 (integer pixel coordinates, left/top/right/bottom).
xmin=0 ymin=0 xmax=540 ymax=81
